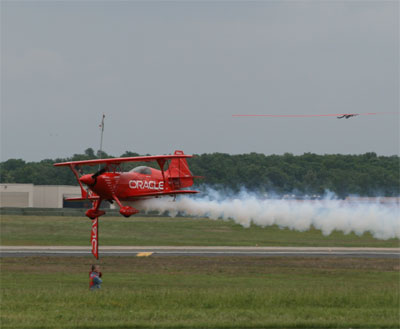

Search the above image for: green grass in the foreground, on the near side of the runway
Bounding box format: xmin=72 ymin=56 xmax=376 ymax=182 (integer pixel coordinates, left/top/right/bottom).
xmin=0 ymin=257 xmax=399 ymax=328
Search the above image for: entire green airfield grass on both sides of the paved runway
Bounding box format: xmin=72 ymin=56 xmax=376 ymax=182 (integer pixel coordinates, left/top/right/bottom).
xmin=0 ymin=215 xmax=400 ymax=329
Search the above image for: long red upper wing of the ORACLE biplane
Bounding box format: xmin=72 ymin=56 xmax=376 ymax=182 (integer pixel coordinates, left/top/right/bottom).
xmin=54 ymin=154 xmax=192 ymax=167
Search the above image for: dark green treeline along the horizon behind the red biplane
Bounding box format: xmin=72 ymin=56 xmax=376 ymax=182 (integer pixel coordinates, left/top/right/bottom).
xmin=0 ymin=149 xmax=400 ymax=197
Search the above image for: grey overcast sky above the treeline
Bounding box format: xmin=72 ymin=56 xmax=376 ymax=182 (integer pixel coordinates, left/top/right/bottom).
xmin=1 ymin=1 xmax=399 ymax=161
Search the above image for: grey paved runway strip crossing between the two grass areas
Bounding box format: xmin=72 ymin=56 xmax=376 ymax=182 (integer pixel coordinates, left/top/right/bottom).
xmin=0 ymin=246 xmax=400 ymax=259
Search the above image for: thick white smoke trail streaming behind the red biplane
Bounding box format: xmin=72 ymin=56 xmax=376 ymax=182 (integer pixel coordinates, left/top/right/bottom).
xmin=136 ymin=191 xmax=400 ymax=240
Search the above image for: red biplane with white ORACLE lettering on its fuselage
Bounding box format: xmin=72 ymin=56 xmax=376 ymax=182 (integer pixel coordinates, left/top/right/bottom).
xmin=54 ymin=151 xmax=197 ymax=219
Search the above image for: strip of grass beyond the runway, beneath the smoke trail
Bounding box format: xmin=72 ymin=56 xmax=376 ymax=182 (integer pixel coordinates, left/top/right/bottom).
xmin=0 ymin=215 xmax=399 ymax=247
